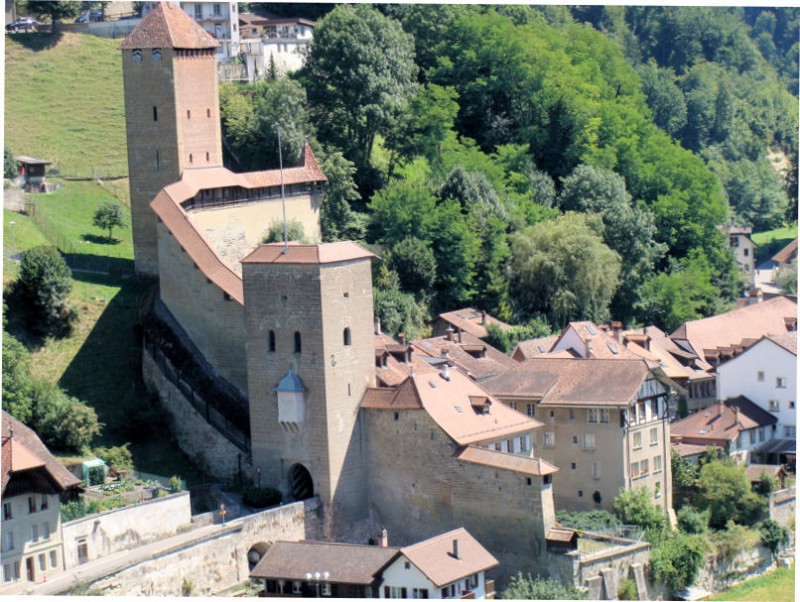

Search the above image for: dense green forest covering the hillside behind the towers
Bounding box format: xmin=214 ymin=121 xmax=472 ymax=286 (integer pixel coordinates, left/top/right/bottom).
xmin=220 ymin=3 xmax=800 ymax=335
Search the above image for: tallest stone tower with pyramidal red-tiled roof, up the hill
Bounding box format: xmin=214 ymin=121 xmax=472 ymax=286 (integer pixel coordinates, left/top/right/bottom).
xmin=120 ymin=2 xmax=222 ymax=275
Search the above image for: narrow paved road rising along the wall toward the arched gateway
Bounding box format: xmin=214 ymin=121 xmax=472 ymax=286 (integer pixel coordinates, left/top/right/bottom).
xmin=3 ymin=521 xmax=242 ymax=596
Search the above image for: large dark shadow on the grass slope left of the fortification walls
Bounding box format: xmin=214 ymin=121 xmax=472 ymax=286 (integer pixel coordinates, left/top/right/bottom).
xmin=59 ymin=272 xmax=204 ymax=483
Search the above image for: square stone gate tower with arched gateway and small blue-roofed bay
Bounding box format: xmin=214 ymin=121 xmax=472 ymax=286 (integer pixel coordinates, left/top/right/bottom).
xmin=242 ymin=242 xmax=375 ymax=536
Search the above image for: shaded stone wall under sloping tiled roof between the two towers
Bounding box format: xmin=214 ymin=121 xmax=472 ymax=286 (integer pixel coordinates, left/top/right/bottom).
xmin=158 ymin=224 xmax=247 ymax=392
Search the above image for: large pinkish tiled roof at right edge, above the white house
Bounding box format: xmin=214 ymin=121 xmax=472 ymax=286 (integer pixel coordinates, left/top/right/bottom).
xmin=670 ymin=296 xmax=797 ymax=361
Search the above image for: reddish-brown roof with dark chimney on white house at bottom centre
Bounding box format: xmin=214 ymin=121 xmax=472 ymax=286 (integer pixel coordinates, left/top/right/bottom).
xmin=401 ymin=528 xmax=500 ymax=587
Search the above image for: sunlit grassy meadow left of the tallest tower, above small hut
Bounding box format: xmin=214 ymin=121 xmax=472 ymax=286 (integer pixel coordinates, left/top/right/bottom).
xmin=5 ymin=33 xmax=128 ymax=180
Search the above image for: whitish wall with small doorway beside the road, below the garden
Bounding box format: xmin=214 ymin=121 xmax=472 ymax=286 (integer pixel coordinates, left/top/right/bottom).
xmin=62 ymin=492 xmax=192 ymax=569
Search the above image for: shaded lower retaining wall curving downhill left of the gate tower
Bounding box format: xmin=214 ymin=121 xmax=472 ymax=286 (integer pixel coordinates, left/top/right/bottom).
xmin=142 ymin=351 xmax=250 ymax=481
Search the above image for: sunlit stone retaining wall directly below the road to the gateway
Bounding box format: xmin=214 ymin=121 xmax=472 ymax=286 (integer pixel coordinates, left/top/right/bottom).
xmin=91 ymin=499 xmax=322 ymax=596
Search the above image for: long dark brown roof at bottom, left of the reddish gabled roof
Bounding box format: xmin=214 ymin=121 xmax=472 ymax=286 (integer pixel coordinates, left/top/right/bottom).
xmin=250 ymin=541 xmax=400 ymax=585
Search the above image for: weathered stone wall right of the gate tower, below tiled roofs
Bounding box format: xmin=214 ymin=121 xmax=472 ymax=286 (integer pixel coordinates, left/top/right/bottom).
xmin=361 ymin=410 xmax=555 ymax=589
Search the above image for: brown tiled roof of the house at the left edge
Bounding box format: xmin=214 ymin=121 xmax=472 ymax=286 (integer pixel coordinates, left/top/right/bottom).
xmin=2 ymin=411 xmax=81 ymax=491
